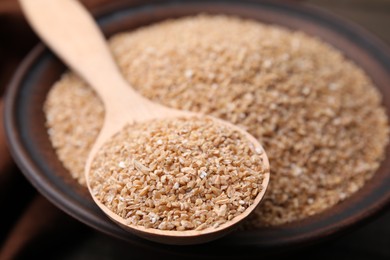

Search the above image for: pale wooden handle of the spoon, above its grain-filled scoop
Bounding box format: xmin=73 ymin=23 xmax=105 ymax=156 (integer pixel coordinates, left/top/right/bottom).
xmin=19 ymin=0 xmax=135 ymax=104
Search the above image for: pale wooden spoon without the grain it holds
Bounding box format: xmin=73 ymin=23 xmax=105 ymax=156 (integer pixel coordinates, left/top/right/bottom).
xmin=20 ymin=0 xmax=269 ymax=244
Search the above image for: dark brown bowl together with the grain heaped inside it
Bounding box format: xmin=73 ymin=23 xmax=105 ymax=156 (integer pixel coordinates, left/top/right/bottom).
xmin=5 ymin=1 xmax=390 ymax=255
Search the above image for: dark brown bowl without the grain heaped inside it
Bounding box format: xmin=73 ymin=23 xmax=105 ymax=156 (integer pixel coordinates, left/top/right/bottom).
xmin=5 ymin=0 xmax=390 ymax=256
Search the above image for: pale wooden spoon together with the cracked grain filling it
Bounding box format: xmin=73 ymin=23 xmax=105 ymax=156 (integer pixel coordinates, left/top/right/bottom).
xmin=20 ymin=0 xmax=269 ymax=244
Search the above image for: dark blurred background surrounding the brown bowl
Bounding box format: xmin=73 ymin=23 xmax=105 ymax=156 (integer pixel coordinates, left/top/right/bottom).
xmin=0 ymin=0 xmax=390 ymax=259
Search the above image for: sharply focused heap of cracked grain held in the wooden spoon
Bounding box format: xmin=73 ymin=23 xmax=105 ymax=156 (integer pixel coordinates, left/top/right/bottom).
xmin=89 ymin=118 xmax=269 ymax=231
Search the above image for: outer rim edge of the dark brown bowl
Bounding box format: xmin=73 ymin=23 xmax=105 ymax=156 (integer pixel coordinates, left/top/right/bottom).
xmin=4 ymin=0 xmax=390 ymax=252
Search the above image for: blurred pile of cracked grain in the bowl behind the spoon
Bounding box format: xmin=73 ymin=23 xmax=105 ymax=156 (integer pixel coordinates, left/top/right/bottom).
xmin=45 ymin=16 xmax=388 ymax=227
